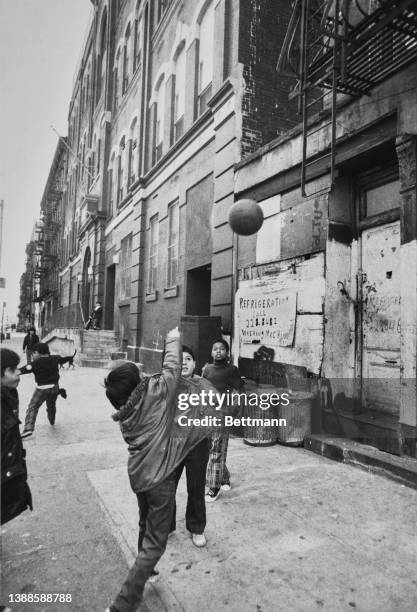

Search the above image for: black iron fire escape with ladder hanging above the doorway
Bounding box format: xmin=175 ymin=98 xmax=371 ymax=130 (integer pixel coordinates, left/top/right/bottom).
xmin=277 ymin=0 xmax=417 ymax=197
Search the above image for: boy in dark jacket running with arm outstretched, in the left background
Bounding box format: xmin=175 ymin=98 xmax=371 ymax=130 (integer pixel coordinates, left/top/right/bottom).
xmin=20 ymin=342 xmax=75 ymax=438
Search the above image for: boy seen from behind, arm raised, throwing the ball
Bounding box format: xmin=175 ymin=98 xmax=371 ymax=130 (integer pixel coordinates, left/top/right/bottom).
xmin=105 ymin=329 xmax=224 ymax=612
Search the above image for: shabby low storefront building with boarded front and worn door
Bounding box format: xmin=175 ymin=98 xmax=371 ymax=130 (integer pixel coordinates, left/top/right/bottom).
xmin=235 ymin=1 xmax=417 ymax=457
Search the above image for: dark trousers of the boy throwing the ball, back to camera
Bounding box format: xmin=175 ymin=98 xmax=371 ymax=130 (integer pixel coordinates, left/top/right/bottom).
xmin=113 ymin=472 xmax=175 ymax=612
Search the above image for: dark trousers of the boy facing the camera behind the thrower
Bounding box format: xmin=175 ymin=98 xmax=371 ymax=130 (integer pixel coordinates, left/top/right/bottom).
xmin=170 ymin=438 xmax=210 ymax=533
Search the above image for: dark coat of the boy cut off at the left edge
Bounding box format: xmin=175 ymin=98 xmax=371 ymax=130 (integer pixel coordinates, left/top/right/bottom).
xmin=1 ymin=387 xmax=32 ymax=524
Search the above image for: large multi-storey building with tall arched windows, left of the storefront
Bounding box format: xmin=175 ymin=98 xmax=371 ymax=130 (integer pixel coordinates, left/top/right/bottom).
xmin=39 ymin=0 xmax=295 ymax=369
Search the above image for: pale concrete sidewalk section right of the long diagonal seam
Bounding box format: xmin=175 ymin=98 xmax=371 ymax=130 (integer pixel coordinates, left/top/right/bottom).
xmin=89 ymin=439 xmax=417 ymax=612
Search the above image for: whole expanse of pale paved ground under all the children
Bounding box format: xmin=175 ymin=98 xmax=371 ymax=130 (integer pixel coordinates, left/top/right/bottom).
xmin=1 ymin=340 xmax=417 ymax=612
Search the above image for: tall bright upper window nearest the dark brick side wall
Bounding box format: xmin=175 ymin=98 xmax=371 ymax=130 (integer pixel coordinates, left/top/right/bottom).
xmin=197 ymin=5 xmax=214 ymax=116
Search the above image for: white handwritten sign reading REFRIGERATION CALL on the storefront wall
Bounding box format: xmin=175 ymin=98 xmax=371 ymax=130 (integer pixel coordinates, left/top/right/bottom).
xmin=236 ymin=287 xmax=297 ymax=346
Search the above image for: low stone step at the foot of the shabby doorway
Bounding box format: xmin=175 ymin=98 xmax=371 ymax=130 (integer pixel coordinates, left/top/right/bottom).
xmin=304 ymin=434 xmax=417 ymax=489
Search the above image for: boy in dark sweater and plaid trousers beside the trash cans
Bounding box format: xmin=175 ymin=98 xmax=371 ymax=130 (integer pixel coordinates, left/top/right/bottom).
xmin=203 ymin=339 xmax=244 ymax=503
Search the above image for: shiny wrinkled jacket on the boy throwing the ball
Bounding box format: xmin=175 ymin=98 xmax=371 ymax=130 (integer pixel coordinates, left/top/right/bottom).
xmin=115 ymin=338 xmax=219 ymax=493
